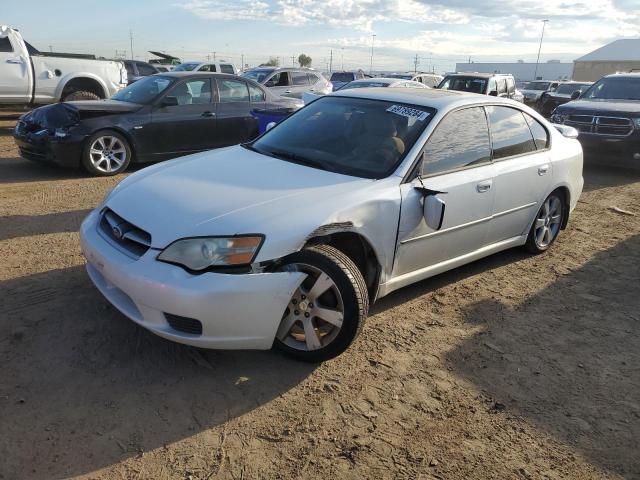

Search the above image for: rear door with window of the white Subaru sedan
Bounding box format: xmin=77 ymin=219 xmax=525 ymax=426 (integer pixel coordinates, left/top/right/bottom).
xmin=487 ymin=106 xmax=552 ymax=243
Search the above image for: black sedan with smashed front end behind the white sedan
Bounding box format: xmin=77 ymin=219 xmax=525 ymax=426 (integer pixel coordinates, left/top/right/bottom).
xmin=14 ymin=72 xmax=302 ymax=176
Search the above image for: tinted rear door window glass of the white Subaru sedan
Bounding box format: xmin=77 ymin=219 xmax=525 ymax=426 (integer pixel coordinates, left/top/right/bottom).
xmin=487 ymin=106 xmax=536 ymax=160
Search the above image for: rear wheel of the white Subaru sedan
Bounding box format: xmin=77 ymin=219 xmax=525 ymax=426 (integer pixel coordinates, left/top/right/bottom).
xmin=525 ymin=190 xmax=567 ymax=254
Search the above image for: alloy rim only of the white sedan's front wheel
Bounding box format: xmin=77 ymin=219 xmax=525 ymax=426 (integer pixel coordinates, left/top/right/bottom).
xmin=276 ymin=263 xmax=344 ymax=351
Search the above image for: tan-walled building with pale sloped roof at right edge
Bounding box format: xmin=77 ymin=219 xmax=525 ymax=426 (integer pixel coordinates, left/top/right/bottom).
xmin=573 ymin=38 xmax=640 ymax=82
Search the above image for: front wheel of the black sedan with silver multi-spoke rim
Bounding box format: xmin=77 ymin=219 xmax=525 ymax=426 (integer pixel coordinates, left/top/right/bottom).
xmin=82 ymin=130 xmax=132 ymax=177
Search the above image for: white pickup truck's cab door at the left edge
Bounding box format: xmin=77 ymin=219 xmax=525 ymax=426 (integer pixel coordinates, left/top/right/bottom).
xmin=0 ymin=33 xmax=31 ymax=103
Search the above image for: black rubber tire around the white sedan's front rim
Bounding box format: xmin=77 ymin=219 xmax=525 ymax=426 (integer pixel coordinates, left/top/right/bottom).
xmin=273 ymin=245 xmax=369 ymax=363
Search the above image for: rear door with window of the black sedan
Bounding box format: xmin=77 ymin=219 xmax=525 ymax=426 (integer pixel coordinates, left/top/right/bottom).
xmin=213 ymin=78 xmax=255 ymax=147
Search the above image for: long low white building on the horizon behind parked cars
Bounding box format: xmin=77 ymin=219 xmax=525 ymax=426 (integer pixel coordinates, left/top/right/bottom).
xmin=456 ymin=60 xmax=573 ymax=81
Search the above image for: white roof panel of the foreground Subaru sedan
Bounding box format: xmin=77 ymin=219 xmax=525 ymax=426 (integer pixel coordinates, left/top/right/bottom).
xmin=331 ymin=87 xmax=518 ymax=110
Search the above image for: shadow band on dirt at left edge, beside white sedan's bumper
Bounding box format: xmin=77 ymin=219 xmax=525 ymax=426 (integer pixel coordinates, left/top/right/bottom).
xmin=0 ymin=209 xmax=91 ymax=241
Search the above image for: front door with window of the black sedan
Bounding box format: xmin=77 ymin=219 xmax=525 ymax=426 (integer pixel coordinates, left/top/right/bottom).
xmin=147 ymin=78 xmax=216 ymax=158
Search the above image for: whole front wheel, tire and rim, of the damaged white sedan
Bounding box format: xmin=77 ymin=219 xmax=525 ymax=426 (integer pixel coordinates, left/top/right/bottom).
xmin=274 ymin=245 xmax=369 ymax=362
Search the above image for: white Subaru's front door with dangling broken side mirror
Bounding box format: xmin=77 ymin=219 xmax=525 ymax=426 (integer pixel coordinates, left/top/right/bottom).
xmin=393 ymin=107 xmax=495 ymax=277
